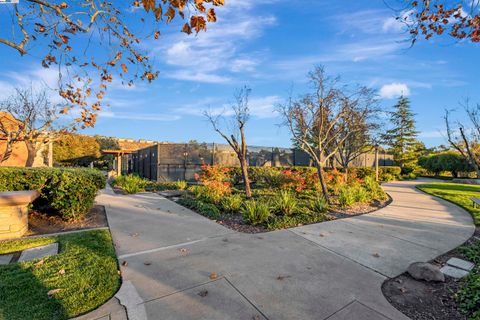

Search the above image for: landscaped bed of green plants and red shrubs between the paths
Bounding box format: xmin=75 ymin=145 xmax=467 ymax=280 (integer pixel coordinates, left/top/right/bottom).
xmin=178 ymin=166 xmax=388 ymax=232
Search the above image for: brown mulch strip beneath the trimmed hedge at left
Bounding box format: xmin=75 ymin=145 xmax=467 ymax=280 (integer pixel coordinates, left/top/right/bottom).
xmin=26 ymin=205 xmax=108 ymax=236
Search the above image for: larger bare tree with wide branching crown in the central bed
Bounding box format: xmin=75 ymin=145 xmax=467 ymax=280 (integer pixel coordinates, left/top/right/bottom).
xmin=279 ymin=67 xmax=373 ymax=200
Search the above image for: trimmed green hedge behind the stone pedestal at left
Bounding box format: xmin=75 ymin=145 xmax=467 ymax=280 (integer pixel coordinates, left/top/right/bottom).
xmin=0 ymin=167 xmax=106 ymax=221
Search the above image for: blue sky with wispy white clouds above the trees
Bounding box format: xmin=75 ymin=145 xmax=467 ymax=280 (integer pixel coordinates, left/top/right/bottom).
xmin=0 ymin=0 xmax=480 ymax=146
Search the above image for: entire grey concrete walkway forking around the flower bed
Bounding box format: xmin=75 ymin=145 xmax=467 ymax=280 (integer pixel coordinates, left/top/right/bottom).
xmin=84 ymin=182 xmax=474 ymax=320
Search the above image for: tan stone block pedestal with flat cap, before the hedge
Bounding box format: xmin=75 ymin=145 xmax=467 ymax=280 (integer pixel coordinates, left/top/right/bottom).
xmin=0 ymin=191 xmax=40 ymax=240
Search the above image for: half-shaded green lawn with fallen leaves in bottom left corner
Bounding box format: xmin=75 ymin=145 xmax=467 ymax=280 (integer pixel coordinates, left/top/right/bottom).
xmin=0 ymin=230 xmax=120 ymax=320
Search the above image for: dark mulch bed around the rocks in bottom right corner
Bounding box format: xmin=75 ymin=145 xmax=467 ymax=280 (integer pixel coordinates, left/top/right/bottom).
xmin=382 ymin=227 xmax=480 ymax=320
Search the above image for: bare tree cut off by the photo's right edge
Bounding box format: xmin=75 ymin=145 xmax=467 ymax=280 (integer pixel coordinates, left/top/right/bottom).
xmin=445 ymin=99 xmax=480 ymax=176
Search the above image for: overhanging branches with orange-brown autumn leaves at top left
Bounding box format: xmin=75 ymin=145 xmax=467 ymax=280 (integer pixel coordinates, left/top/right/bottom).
xmin=0 ymin=0 xmax=224 ymax=127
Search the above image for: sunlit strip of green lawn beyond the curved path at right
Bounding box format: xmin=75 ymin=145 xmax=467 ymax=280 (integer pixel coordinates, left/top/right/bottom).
xmin=417 ymin=182 xmax=480 ymax=226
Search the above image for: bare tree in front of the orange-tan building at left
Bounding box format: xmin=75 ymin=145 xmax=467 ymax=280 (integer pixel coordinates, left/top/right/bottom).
xmin=0 ymin=87 xmax=58 ymax=167
